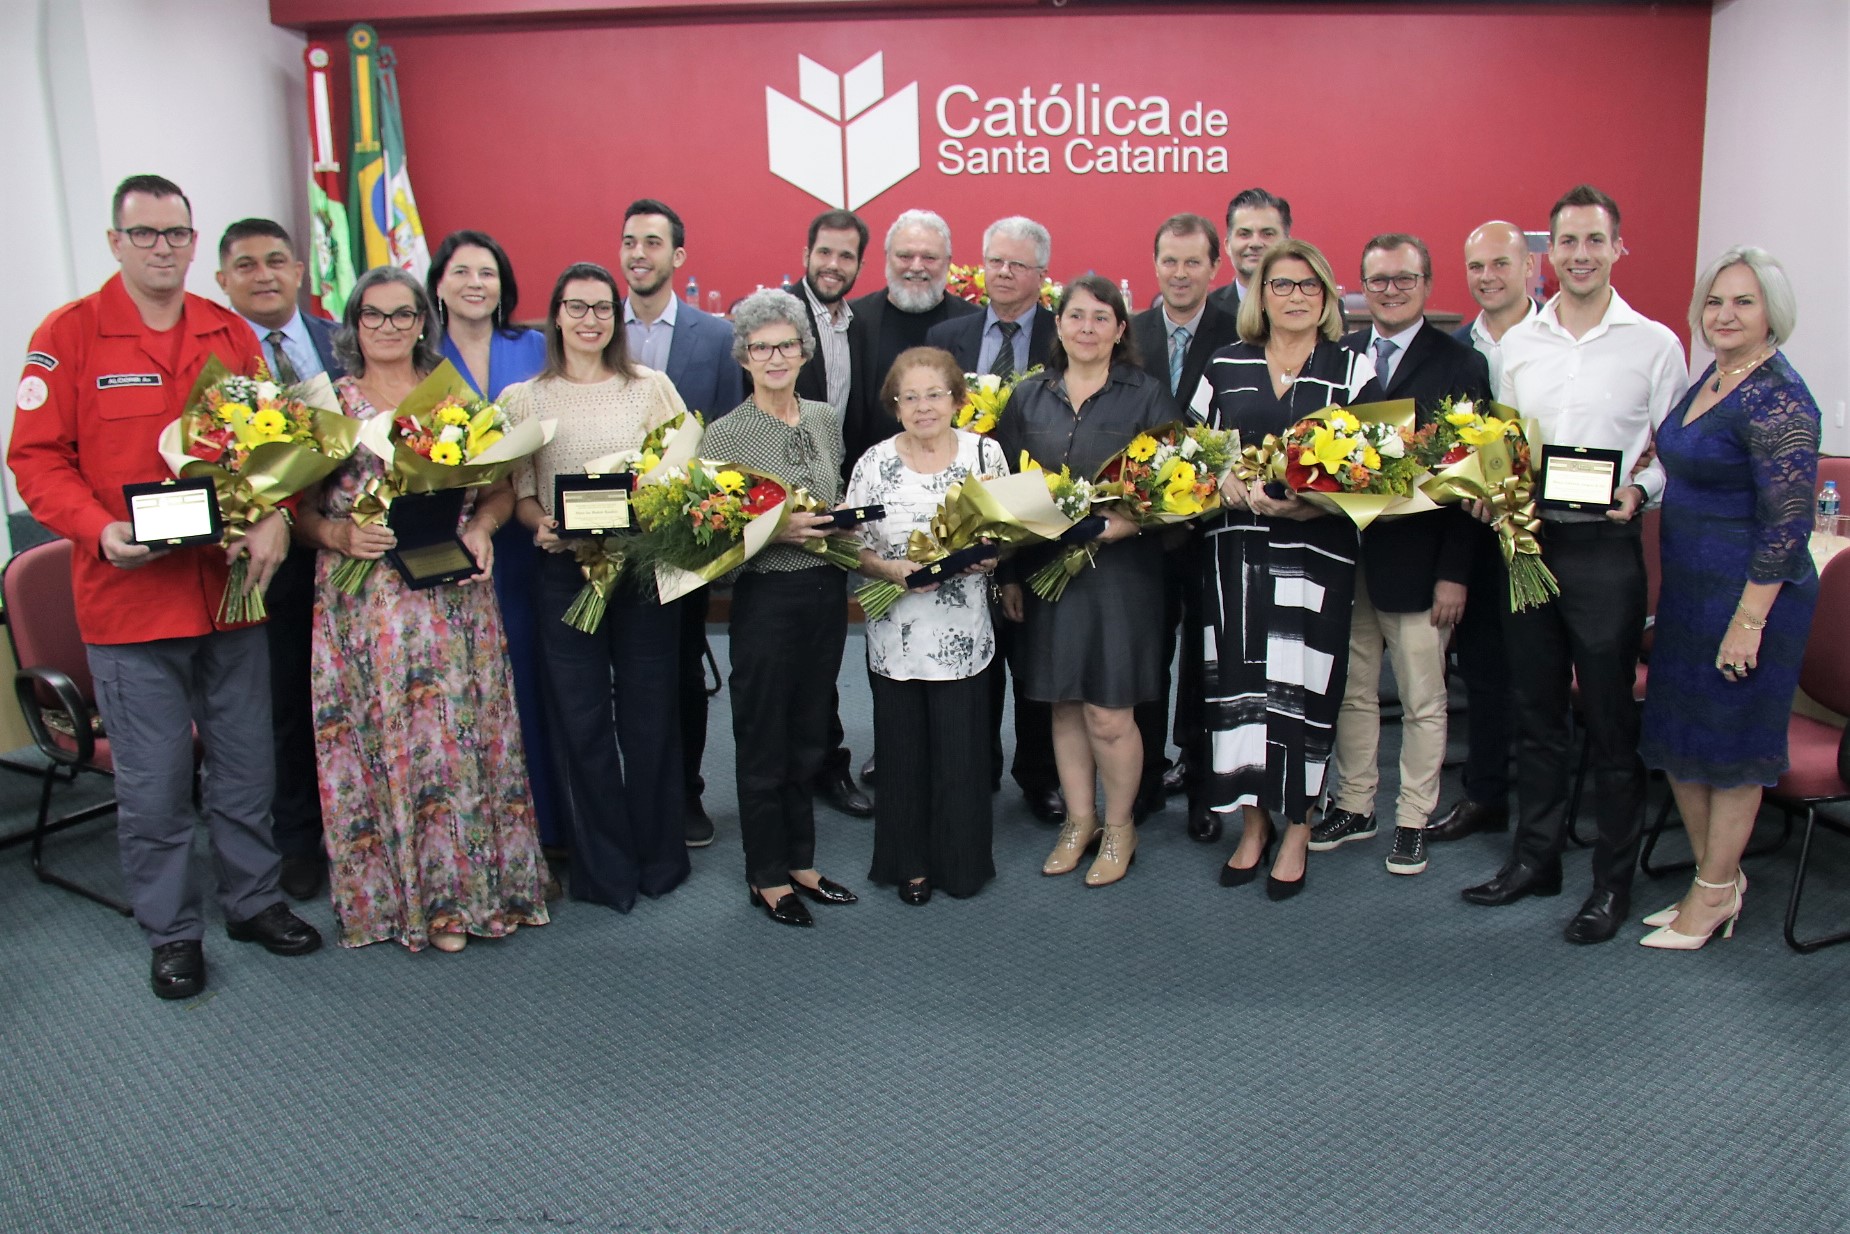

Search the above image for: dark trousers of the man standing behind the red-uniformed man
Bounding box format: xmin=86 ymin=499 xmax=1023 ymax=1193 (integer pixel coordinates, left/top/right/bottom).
xmin=263 ymin=544 xmax=322 ymax=857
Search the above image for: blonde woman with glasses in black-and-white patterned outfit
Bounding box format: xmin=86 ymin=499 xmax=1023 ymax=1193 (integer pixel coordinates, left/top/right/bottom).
xmin=1193 ymin=239 xmax=1380 ymax=899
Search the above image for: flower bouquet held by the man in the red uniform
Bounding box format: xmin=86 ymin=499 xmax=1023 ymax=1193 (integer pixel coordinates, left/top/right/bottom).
xmin=159 ymin=357 xmax=361 ymax=623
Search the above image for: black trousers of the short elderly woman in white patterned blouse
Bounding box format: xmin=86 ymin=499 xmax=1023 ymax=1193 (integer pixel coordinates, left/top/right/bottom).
xmin=868 ymin=664 xmax=1001 ymax=895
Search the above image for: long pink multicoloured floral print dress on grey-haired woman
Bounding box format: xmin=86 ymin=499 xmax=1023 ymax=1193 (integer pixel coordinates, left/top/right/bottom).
xmin=313 ymin=379 xmax=548 ymax=951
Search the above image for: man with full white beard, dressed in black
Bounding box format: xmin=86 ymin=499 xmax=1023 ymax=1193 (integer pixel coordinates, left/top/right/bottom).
xmin=842 ymin=209 xmax=981 ymax=474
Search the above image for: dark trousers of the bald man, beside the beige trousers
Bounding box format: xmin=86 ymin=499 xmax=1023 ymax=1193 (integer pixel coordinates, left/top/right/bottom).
xmin=1454 ymin=527 xmax=1513 ymax=807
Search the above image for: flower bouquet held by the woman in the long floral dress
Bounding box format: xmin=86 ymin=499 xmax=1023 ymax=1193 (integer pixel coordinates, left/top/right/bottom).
xmin=329 ymin=361 xmax=557 ymax=596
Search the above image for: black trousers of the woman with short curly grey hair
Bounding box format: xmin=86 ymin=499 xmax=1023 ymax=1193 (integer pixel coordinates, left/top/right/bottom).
xmin=729 ymin=566 xmax=847 ymax=888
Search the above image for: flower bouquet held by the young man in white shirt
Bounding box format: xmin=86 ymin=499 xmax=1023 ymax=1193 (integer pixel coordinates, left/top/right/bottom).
xmin=1421 ymin=400 xmax=1561 ymax=612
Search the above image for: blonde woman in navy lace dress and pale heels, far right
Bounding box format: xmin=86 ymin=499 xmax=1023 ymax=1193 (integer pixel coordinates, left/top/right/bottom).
xmin=1639 ymin=248 xmax=1819 ymax=951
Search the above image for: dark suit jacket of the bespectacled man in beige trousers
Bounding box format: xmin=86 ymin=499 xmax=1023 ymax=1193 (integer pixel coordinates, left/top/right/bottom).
xmin=1343 ymin=322 xmax=1491 ymax=612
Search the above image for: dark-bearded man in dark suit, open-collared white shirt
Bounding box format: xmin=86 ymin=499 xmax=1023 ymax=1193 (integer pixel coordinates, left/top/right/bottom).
xmin=784 ymin=209 xmax=873 ymax=818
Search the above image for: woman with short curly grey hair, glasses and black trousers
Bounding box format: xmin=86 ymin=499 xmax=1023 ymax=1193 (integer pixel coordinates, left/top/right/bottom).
xmin=701 ymin=290 xmax=855 ymax=925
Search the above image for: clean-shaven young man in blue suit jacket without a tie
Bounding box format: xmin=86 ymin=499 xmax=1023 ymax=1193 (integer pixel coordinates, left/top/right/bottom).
xmin=622 ymin=198 xmax=746 ymax=847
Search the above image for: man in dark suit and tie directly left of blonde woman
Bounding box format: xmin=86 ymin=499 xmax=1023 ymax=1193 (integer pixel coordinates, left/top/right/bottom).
xmin=1130 ymin=215 xmax=1240 ymax=842
